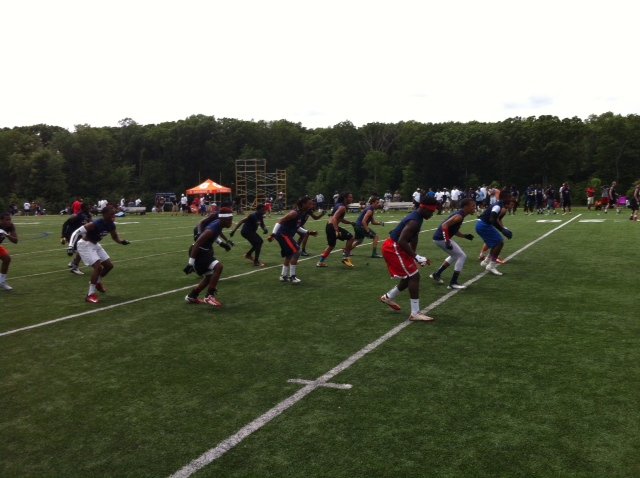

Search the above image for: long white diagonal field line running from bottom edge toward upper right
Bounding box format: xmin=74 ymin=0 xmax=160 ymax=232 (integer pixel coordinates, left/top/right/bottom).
xmin=170 ymin=215 xmax=580 ymax=478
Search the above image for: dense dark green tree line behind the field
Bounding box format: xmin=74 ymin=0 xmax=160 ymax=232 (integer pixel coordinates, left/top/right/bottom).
xmin=0 ymin=113 xmax=640 ymax=212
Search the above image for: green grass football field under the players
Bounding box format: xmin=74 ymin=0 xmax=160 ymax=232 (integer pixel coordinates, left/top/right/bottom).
xmin=0 ymin=210 xmax=640 ymax=478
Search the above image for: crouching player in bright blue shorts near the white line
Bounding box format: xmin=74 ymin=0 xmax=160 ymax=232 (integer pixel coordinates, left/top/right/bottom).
xmin=476 ymin=189 xmax=513 ymax=276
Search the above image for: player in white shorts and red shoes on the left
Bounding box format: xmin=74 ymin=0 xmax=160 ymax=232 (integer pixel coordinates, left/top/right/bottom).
xmin=69 ymin=204 xmax=129 ymax=304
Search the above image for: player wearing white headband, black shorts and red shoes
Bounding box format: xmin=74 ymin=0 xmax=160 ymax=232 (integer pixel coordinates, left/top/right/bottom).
xmin=184 ymin=207 xmax=233 ymax=307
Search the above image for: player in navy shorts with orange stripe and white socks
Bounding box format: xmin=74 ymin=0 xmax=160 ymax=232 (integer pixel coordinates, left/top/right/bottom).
xmin=269 ymin=196 xmax=317 ymax=284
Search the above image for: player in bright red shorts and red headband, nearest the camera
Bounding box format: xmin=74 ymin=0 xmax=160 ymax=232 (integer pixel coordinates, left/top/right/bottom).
xmin=380 ymin=196 xmax=438 ymax=322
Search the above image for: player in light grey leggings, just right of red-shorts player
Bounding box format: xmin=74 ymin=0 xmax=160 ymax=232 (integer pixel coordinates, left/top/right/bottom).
xmin=429 ymin=198 xmax=476 ymax=289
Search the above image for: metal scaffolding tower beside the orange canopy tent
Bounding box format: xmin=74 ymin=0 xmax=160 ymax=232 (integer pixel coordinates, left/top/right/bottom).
xmin=236 ymin=159 xmax=287 ymax=211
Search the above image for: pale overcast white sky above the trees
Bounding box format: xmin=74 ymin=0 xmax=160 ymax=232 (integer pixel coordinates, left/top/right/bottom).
xmin=0 ymin=0 xmax=640 ymax=129
